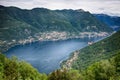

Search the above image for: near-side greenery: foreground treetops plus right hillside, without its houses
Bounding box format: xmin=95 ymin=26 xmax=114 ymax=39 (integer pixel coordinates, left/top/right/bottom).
xmin=0 ymin=32 xmax=120 ymax=80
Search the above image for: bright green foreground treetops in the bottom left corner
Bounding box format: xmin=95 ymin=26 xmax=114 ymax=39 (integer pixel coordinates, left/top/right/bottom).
xmin=0 ymin=54 xmax=47 ymax=80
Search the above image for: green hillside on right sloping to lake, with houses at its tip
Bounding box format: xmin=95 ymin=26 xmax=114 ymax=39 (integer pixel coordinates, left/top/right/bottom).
xmin=63 ymin=31 xmax=120 ymax=70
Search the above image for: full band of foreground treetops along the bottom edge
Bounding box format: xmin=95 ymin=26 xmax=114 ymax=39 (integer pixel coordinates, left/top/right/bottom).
xmin=0 ymin=52 xmax=120 ymax=80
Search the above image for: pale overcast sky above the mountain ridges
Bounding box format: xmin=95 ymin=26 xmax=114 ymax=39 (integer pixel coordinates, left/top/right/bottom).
xmin=0 ymin=0 xmax=120 ymax=16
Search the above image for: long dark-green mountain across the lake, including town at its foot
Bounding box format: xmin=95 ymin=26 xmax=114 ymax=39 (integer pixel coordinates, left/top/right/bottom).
xmin=0 ymin=6 xmax=112 ymax=51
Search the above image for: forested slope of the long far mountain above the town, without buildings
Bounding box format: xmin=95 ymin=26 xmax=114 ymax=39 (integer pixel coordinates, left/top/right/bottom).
xmin=0 ymin=7 xmax=112 ymax=39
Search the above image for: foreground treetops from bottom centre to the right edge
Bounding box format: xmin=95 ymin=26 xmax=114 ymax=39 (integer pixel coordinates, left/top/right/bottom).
xmin=48 ymin=52 xmax=120 ymax=80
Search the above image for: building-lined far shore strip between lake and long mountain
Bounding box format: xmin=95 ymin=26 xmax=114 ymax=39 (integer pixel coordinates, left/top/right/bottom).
xmin=0 ymin=31 xmax=112 ymax=52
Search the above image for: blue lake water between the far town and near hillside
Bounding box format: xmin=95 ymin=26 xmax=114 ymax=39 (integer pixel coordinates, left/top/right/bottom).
xmin=5 ymin=38 xmax=101 ymax=73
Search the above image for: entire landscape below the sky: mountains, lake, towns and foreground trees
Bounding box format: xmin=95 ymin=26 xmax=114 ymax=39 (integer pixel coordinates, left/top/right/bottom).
xmin=0 ymin=5 xmax=120 ymax=80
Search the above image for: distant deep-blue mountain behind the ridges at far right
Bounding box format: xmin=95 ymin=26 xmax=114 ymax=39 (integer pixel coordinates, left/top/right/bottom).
xmin=94 ymin=14 xmax=120 ymax=31
